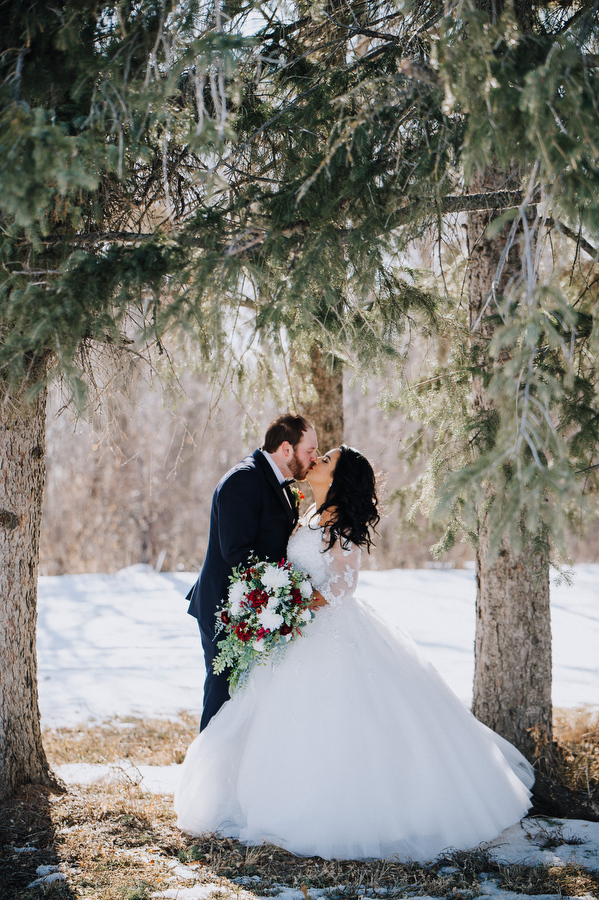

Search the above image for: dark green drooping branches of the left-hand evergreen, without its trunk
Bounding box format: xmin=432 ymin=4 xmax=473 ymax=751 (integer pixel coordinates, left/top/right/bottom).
xmin=0 ymin=0 xmax=247 ymax=393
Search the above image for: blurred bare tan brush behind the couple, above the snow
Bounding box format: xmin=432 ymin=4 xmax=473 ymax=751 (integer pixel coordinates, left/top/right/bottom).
xmin=40 ymin=353 xmax=599 ymax=575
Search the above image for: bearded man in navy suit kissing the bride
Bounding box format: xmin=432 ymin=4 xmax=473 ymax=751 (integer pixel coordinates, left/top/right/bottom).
xmin=187 ymin=414 xmax=317 ymax=731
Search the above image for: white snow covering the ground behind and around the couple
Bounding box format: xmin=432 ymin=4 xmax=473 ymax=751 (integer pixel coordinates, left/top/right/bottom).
xmin=38 ymin=565 xmax=599 ymax=900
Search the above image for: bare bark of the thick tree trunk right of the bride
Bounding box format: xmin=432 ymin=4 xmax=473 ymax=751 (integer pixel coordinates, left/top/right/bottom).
xmin=468 ymin=168 xmax=552 ymax=761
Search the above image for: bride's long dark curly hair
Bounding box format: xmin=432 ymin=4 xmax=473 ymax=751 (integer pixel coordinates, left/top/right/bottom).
xmin=317 ymin=444 xmax=381 ymax=553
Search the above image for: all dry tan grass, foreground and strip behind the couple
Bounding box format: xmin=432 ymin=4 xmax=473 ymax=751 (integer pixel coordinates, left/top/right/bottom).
xmin=0 ymin=713 xmax=599 ymax=900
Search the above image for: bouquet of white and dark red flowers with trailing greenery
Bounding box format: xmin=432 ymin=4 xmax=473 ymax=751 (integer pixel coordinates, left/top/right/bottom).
xmin=212 ymin=557 xmax=314 ymax=690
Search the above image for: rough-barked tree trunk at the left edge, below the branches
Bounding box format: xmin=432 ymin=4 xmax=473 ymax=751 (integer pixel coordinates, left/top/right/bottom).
xmin=0 ymin=376 xmax=57 ymax=800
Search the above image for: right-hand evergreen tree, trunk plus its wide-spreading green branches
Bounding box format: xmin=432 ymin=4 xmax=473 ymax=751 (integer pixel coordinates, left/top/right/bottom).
xmin=191 ymin=0 xmax=599 ymax=792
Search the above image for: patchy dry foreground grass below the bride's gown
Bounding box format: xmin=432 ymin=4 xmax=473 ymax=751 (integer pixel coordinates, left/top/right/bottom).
xmin=0 ymin=783 xmax=599 ymax=900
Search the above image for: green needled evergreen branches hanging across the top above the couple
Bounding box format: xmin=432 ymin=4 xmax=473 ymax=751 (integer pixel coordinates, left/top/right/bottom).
xmin=0 ymin=0 xmax=599 ymax=816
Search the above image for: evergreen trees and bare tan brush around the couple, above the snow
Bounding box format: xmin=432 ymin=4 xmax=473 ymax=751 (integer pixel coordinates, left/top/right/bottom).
xmin=0 ymin=0 xmax=599 ymax=815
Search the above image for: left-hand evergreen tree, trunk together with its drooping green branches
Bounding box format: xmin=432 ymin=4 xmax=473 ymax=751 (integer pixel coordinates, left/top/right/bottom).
xmin=0 ymin=0 xmax=243 ymax=797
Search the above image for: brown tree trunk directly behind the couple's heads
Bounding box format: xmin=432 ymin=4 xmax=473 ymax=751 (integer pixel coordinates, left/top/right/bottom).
xmin=301 ymin=346 xmax=344 ymax=453
